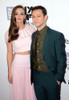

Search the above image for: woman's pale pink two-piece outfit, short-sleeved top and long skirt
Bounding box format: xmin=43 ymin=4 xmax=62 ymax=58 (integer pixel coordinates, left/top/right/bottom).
xmin=5 ymin=25 xmax=36 ymax=100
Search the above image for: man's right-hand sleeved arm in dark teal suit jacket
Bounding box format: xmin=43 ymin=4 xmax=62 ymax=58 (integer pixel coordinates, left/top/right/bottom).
xmin=55 ymin=33 xmax=66 ymax=84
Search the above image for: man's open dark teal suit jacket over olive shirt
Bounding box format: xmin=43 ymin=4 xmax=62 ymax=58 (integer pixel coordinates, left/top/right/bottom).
xmin=30 ymin=27 xmax=66 ymax=82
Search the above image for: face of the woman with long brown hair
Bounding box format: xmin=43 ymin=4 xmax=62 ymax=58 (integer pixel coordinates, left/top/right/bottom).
xmin=15 ymin=8 xmax=26 ymax=24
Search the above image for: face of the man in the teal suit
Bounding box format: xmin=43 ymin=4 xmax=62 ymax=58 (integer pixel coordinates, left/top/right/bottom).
xmin=32 ymin=9 xmax=47 ymax=28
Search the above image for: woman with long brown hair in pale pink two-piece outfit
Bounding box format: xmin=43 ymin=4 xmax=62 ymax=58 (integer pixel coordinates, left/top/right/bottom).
xmin=5 ymin=5 xmax=36 ymax=100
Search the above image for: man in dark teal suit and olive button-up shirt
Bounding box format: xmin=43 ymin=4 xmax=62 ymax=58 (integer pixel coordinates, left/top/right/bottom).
xmin=31 ymin=6 xmax=66 ymax=100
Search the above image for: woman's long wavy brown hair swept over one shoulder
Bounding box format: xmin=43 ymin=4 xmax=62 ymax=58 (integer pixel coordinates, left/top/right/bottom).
xmin=8 ymin=5 xmax=26 ymax=42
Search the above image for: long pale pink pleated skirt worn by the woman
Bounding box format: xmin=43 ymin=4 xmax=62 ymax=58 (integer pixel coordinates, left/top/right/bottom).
xmin=10 ymin=54 xmax=36 ymax=100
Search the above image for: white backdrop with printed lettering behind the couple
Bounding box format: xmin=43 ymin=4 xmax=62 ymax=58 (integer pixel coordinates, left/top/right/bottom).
xmin=0 ymin=0 xmax=69 ymax=100
